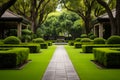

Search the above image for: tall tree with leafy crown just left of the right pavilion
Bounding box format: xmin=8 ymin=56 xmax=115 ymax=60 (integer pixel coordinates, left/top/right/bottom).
xmin=62 ymin=0 xmax=95 ymax=34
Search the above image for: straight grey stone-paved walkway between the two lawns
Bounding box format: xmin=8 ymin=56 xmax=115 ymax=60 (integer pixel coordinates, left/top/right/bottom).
xmin=42 ymin=45 xmax=80 ymax=80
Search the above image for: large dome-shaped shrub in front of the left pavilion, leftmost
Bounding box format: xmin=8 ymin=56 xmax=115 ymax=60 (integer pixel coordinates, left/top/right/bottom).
xmin=4 ymin=36 xmax=21 ymax=44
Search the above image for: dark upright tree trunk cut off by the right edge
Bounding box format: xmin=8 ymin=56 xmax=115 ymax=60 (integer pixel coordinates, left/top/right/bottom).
xmin=116 ymin=0 xmax=120 ymax=35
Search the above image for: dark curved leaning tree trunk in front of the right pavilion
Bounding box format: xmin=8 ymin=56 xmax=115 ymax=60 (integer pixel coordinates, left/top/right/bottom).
xmin=97 ymin=0 xmax=119 ymax=35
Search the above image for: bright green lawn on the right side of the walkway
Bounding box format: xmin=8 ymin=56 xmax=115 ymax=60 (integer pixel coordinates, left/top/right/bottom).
xmin=65 ymin=46 xmax=120 ymax=80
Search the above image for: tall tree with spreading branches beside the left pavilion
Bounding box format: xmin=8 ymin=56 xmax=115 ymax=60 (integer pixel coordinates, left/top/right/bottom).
xmin=12 ymin=0 xmax=57 ymax=33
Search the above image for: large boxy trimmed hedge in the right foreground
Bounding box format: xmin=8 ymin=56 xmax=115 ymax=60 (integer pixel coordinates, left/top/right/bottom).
xmin=93 ymin=48 xmax=120 ymax=68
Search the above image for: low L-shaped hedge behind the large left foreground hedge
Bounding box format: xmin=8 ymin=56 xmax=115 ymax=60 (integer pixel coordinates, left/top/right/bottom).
xmin=0 ymin=44 xmax=40 ymax=53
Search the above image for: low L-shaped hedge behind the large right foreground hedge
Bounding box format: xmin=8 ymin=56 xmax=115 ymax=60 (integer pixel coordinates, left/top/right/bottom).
xmin=82 ymin=44 xmax=120 ymax=53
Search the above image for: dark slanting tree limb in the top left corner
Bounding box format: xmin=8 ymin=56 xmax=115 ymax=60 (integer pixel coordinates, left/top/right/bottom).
xmin=0 ymin=0 xmax=17 ymax=17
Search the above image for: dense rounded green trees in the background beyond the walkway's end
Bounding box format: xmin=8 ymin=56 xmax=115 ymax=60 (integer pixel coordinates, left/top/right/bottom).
xmin=37 ymin=10 xmax=83 ymax=38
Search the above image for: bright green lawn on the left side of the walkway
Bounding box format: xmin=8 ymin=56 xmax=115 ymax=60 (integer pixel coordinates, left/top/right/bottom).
xmin=0 ymin=46 xmax=56 ymax=80
